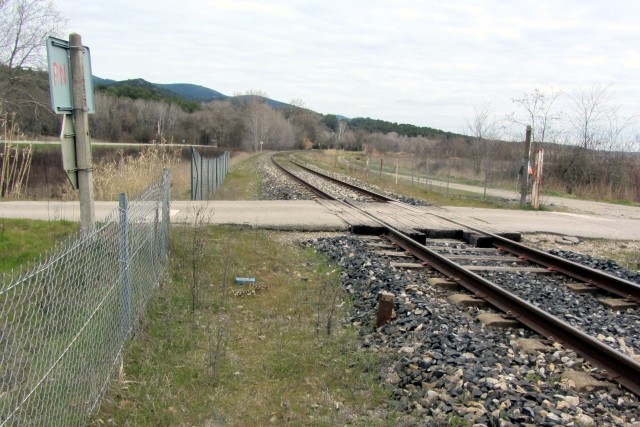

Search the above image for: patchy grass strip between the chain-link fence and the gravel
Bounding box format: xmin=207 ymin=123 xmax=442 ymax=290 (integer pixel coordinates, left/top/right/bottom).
xmin=93 ymin=226 xmax=398 ymax=426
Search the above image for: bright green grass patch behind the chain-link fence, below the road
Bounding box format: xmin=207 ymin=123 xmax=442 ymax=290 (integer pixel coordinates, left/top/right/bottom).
xmin=0 ymin=218 xmax=79 ymax=272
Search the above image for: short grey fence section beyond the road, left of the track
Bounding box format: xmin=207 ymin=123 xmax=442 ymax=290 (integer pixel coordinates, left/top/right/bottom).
xmin=191 ymin=147 xmax=229 ymax=200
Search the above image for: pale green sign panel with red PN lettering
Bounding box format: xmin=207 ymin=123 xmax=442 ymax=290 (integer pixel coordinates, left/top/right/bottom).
xmin=47 ymin=37 xmax=96 ymax=114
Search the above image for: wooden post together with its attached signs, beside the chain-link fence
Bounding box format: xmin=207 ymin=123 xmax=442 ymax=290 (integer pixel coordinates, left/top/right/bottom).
xmin=47 ymin=33 xmax=95 ymax=232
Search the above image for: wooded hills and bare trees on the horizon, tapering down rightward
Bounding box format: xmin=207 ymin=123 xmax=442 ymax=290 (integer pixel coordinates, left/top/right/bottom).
xmin=0 ymin=65 xmax=459 ymax=149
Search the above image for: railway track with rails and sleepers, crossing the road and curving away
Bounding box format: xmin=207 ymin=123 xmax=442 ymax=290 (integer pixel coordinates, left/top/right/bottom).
xmin=272 ymin=152 xmax=640 ymax=395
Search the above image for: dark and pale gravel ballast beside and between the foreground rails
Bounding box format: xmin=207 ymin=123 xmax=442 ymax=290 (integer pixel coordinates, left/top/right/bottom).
xmin=308 ymin=236 xmax=640 ymax=426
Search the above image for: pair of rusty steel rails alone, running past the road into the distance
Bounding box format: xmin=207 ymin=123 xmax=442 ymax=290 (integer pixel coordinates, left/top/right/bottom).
xmin=274 ymin=155 xmax=640 ymax=395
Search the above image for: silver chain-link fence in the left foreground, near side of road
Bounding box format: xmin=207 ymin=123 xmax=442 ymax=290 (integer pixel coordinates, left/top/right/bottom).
xmin=0 ymin=170 xmax=169 ymax=426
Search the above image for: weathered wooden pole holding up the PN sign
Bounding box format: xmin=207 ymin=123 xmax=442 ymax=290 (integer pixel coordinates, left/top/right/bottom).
xmin=69 ymin=33 xmax=95 ymax=232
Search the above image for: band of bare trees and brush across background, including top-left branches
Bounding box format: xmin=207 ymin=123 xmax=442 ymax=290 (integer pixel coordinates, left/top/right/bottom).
xmin=0 ymin=0 xmax=640 ymax=201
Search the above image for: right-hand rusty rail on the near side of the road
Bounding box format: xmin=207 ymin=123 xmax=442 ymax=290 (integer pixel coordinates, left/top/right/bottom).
xmin=432 ymin=213 xmax=640 ymax=303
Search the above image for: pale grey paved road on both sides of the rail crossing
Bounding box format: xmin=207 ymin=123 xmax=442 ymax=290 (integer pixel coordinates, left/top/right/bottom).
xmin=0 ymin=200 xmax=640 ymax=240
